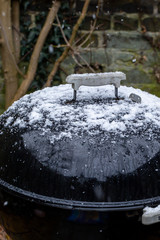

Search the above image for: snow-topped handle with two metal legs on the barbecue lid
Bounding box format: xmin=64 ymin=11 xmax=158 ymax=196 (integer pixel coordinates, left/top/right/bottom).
xmin=66 ymin=72 xmax=126 ymax=101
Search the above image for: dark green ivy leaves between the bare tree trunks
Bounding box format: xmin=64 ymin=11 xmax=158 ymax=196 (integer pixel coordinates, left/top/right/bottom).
xmin=20 ymin=1 xmax=71 ymax=91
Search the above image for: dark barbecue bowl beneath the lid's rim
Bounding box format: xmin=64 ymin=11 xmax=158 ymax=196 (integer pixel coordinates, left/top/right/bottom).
xmin=0 ymin=188 xmax=160 ymax=240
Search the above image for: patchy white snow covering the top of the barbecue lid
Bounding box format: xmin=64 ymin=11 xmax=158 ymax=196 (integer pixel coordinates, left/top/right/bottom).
xmin=0 ymin=84 xmax=160 ymax=141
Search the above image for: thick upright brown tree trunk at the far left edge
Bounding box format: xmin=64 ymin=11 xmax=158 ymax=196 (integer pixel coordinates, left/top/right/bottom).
xmin=0 ymin=0 xmax=18 ymax=108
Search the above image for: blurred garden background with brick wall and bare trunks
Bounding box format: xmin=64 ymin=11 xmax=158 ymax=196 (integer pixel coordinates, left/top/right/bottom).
xmin=0 ymin=0 xmax=160 ymax=113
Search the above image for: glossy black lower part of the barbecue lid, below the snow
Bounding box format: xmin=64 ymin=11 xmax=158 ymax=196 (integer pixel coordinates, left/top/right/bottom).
xmin=0 ymin=124 xmax=160 ymax=210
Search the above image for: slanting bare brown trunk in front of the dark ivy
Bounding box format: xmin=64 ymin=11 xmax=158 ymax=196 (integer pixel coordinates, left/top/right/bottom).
xmin=13 ymin=1 xmax=61 ymax=102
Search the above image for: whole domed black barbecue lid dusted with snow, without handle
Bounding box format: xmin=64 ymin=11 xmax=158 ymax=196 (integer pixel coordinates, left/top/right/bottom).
xmin=0 ymin=81 xmax=160 ymax=210
